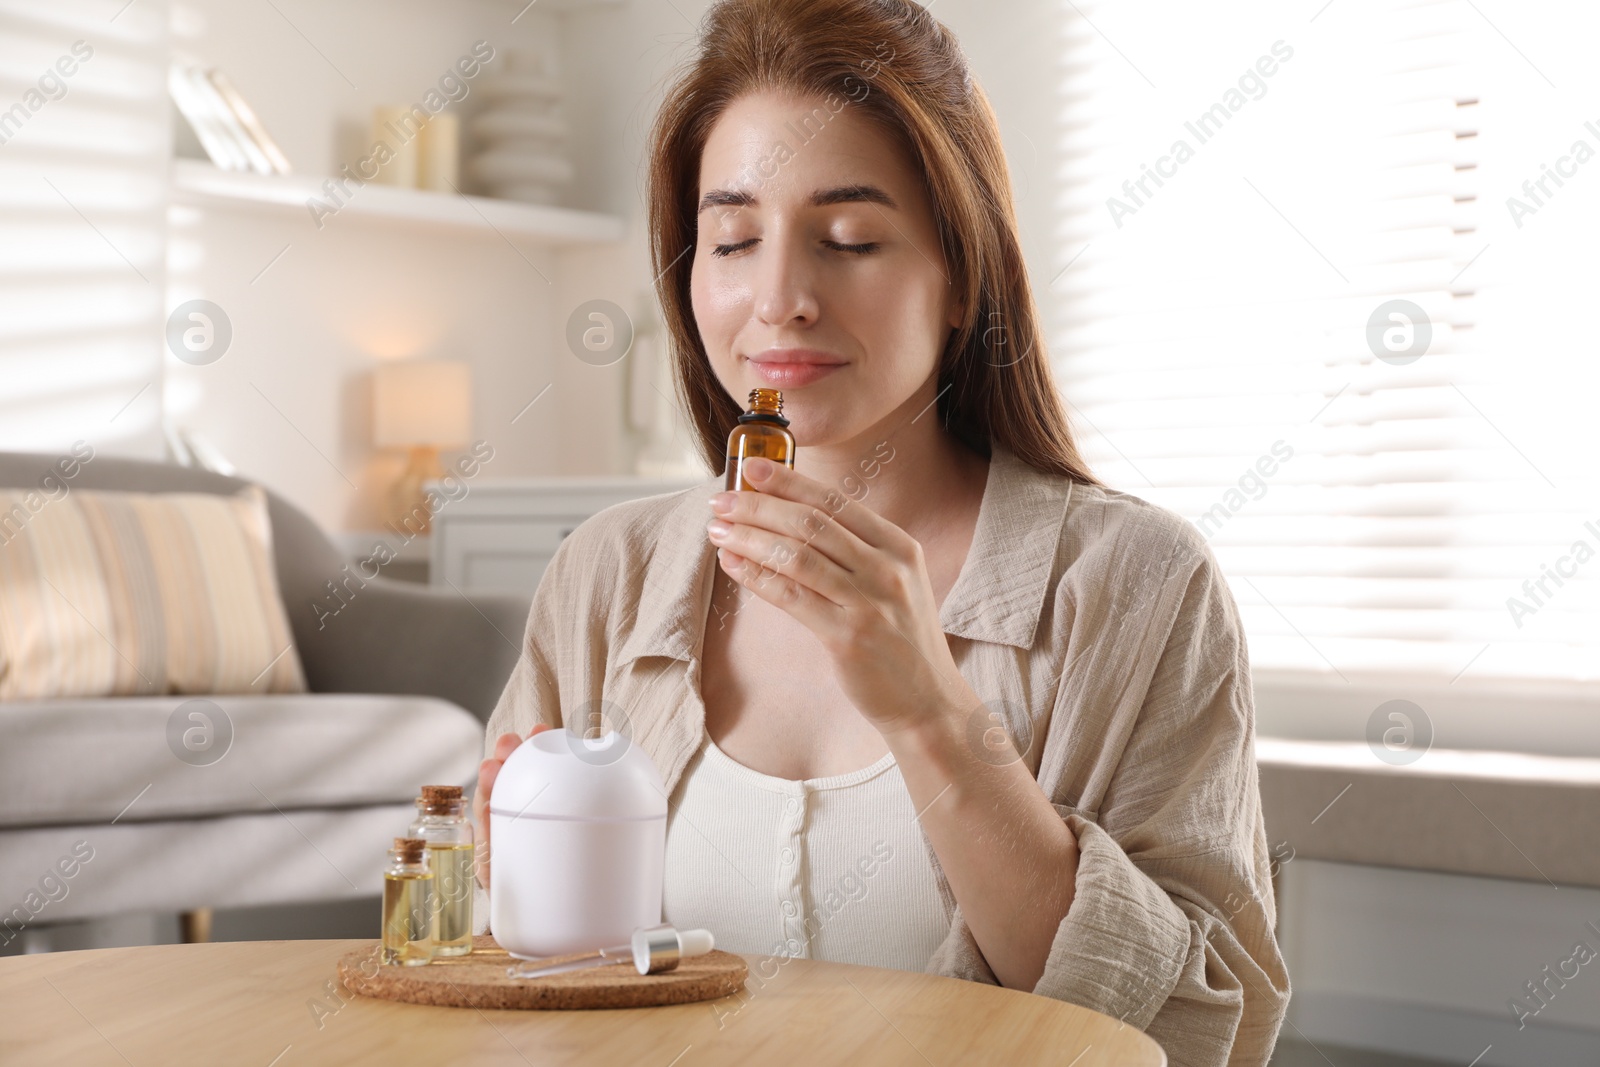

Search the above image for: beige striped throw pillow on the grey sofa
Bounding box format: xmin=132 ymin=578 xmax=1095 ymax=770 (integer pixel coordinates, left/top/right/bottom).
xmin=0 ymin=486 xmax=306 ymax=701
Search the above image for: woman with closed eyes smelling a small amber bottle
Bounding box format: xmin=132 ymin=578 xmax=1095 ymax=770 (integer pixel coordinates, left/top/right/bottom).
xmin=475 ymin=0 xmax=1288 ymax=1064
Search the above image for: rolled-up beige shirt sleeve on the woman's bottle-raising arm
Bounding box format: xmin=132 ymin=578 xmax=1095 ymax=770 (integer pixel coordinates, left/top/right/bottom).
xmin=928 ymin=523 xmax=1290 ymax=1067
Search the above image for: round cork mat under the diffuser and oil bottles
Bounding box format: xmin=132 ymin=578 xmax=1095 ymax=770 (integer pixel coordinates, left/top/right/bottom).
xmin=339 ymin=934 xmax=749 ymax=1011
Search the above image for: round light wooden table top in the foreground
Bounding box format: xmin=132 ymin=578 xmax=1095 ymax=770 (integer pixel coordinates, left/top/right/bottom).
xmin=0 ymin=941 xmax=1166 ymax=1067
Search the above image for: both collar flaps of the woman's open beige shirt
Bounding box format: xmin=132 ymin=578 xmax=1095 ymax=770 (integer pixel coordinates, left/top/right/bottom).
xmin=618 ymin=443 xmax=1072 ymax=662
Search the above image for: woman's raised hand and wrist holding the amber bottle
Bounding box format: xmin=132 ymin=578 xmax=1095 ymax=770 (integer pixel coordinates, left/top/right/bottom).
xmin=707 ymin=459 xmax=979 ymax=734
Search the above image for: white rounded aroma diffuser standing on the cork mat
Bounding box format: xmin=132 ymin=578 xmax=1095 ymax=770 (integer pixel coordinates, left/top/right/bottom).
xmin=490 ymin=729 xmax=667 ymax=960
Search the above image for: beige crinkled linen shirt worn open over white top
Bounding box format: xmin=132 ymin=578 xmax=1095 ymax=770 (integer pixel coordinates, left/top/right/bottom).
xmin=478 ymin=446 xmax=1290 ymax=1067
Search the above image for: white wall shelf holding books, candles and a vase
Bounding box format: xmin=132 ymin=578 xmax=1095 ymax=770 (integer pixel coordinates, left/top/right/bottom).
xmin=173 ymin=158 xmax=622 ymax=246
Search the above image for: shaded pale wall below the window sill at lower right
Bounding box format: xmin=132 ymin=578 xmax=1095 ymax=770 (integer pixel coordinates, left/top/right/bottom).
xmin=1280 ymin=857 xmax=1600 ymax=1067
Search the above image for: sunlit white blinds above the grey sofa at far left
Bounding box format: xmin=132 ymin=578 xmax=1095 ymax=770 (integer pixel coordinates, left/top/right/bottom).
xmin=0 ymin=0 xmax=171 ymax=454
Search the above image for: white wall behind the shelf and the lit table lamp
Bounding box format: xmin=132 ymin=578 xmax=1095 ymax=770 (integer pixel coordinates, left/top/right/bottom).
xmin=165 ymin=0 xmax=675 ymax=531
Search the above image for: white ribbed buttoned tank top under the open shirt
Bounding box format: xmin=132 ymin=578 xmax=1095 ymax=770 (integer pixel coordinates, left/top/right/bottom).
xmin=661 ymin=734 xmax=950 ymax=971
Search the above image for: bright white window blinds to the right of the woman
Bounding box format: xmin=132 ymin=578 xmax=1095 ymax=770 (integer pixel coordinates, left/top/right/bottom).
xmin=1043 ymin=0 xmax=1600 ymax=680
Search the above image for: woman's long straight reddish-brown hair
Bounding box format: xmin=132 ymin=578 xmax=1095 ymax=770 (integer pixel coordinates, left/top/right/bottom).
xmin=648 ymin=0 xmax=1099 ymax=485
